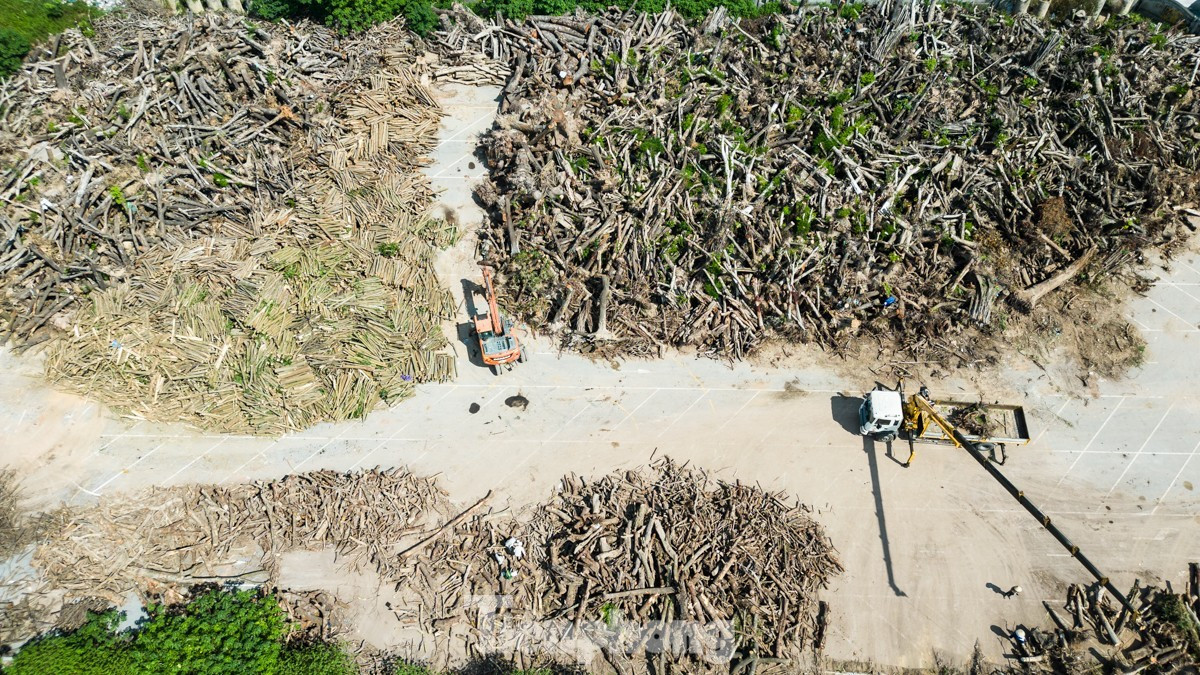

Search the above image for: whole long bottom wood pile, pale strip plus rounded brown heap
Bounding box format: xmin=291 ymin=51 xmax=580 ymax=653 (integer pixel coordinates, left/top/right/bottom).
xmin=18 ymin=460 xmax=841 ymax=665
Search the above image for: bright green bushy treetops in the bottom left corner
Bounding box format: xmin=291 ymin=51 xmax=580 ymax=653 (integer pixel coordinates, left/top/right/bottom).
xmin=5 ymin=586 xmax=356 ymax=675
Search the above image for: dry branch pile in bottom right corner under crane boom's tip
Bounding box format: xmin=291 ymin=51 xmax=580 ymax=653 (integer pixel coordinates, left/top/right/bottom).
xmin=1014 ymin=563 xmax=1200 ymax=673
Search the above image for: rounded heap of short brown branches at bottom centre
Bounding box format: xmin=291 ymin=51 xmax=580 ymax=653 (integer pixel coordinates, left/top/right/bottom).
xmin=540 ymin=460 xmax=841 ymax=657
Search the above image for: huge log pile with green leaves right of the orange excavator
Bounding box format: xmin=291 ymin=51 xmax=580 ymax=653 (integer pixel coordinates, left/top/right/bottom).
xmin=460 ymin=2 xmax=1200 ymax=357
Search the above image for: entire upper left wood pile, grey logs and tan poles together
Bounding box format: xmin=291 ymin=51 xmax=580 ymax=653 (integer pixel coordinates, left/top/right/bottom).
xmin=0 ymin=16 xmax=457 ymax=434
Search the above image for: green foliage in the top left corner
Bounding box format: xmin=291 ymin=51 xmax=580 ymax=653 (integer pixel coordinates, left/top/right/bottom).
xmin=0 ymin=0 xmax=101 ymax=77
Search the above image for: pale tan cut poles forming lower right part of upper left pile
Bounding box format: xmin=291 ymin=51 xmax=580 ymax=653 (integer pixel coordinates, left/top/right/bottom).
xmin=38 ymin=53 xmax=457 ymax=434
